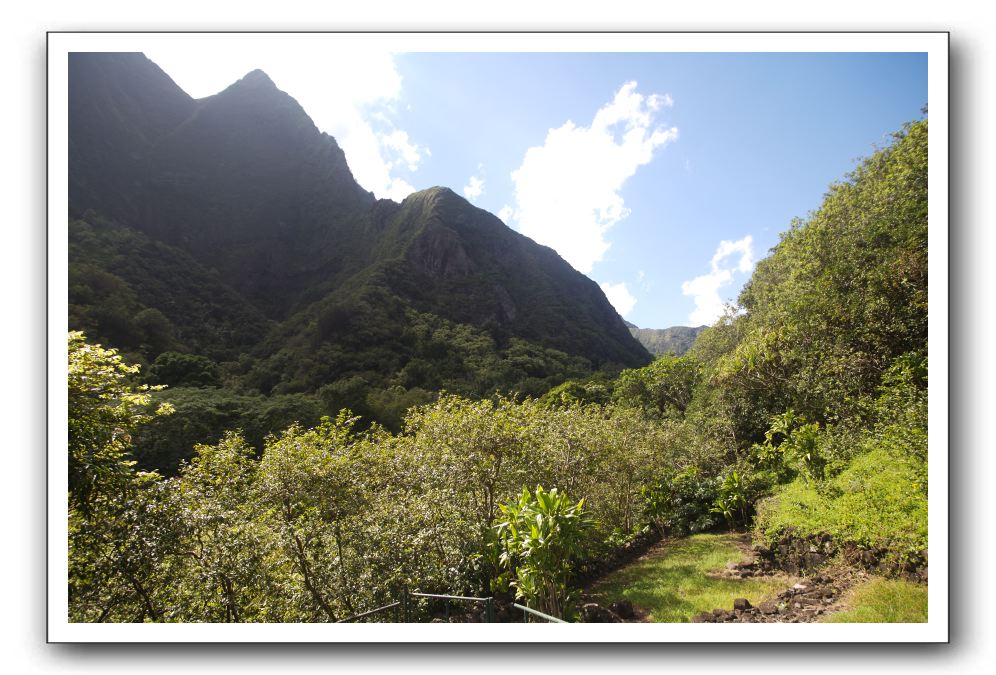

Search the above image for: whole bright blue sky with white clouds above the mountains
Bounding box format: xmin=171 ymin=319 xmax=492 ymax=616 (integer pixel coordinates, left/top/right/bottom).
xmin=146 ymin=50 xmax=927 ymax=328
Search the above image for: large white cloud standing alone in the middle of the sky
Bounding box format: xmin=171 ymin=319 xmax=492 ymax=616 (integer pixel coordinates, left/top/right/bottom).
xmin=499 ymin=82 xmax=678 ymax=274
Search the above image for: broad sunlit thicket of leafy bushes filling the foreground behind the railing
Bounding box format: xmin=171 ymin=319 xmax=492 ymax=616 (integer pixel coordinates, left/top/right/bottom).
xmin=70 ymin=336 xmax=689 ymax=621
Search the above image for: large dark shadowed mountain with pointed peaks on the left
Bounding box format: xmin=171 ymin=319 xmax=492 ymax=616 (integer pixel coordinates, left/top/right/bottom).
xmin=69 ymin=53 xmax=650 ymax=412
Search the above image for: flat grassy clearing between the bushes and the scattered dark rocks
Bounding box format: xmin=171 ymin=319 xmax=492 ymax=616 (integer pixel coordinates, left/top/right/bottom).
xmin=590 ymin=534 xmax=791 ymax=623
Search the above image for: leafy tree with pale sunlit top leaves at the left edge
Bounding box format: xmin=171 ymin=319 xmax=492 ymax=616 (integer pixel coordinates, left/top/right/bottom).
xmin=68 ymin=332 xmax=172 ymax=621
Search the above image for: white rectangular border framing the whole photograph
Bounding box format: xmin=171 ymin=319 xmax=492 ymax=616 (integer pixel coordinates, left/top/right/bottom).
xmin=47 ymin=31 xmax=950 ymax=643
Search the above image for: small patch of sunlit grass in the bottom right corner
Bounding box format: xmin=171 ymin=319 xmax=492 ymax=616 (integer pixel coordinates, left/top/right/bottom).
xmin=823 ymin=577 xmax=927 ymax=623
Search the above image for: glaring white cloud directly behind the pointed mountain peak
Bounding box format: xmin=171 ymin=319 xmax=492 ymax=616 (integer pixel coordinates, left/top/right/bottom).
xmin=145 ymin=41 xmax=429 ymax=200
